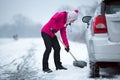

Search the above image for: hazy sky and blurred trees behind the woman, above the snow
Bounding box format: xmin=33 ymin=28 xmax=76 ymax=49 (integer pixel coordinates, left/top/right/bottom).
xmin=0 ymin=0 xmax=101 ymax=42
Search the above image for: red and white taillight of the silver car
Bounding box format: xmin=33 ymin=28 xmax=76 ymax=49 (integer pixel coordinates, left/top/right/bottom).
xmin=93 ymin=15 xmax=107 ymax=34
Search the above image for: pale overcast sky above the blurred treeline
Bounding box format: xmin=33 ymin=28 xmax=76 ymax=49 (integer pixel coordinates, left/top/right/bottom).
xmin=0 ymin=0 xmax=99 ymax=25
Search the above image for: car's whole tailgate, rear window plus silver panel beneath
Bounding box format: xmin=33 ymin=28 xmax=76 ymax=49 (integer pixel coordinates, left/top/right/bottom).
xmin=105 ymin=0 xmax=120 ymax=42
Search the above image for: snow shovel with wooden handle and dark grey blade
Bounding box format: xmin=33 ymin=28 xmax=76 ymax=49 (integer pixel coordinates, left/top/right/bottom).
xmin=57 ymin=37 xmax=87 ymax=68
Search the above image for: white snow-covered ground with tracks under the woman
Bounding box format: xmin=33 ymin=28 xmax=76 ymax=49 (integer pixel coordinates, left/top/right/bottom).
xmin=0 ymin=38 xmax=120 ymax=80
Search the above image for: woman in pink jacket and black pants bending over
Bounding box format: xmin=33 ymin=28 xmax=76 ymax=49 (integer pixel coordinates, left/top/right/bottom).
xmin=41 ymin=10 xmax=78 ymax=73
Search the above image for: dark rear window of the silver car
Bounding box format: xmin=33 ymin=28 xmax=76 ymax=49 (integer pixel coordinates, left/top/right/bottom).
xmin=105 ymin=0 xmax=120 ymax=14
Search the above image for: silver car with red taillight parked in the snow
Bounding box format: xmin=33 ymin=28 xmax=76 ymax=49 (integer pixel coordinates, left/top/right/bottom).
xmin=82 ymin=0 xmax=120 ymax=77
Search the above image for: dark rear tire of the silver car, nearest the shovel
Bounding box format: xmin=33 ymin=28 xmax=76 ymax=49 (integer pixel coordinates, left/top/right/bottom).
xmin=90 ymin=61 xmax=100 ymax=78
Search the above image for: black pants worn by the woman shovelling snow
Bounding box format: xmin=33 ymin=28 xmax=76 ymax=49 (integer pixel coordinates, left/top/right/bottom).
xmin=42 ymin=32 xmax=61 ymax=70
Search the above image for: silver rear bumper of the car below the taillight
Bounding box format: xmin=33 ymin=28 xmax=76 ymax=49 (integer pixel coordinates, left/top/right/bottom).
xmin=91 ymin=34 xmax=120 ymax=62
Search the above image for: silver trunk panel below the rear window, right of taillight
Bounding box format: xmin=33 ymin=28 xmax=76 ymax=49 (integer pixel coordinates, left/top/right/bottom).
xmin=106 ymin=13 xmax=120 ymax=42
